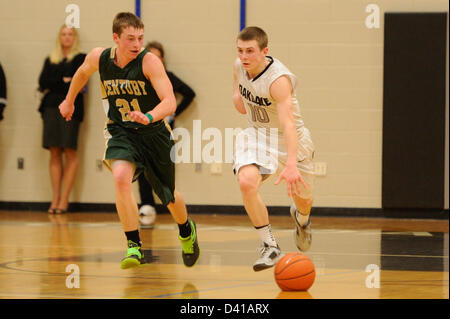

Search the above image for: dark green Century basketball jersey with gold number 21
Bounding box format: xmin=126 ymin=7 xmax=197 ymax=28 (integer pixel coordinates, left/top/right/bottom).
xmin=99 ymin=48 xmax=160 ymax=128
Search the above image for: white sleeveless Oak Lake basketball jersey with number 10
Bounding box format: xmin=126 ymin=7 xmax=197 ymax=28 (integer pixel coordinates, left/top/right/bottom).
xmin=236 ymin=56 xmax=304 ymax=148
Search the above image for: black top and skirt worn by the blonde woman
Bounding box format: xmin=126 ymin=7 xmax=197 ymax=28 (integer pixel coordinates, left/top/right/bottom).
xmin=39 ymin=53 xmax=86 ymax=150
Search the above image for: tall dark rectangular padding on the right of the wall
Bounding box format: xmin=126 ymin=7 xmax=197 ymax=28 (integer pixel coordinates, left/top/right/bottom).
xmin=382 ymin=13 xmax=447 ymax=209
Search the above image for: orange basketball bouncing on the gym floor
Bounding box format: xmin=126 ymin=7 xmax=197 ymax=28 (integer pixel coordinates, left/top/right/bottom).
xmin=274 ymin=253 xmax=316 ymax=291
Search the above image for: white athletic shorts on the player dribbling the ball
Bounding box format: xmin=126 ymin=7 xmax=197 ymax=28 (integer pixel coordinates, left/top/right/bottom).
xmin=233 ymin=127 xmax=314 ymax=198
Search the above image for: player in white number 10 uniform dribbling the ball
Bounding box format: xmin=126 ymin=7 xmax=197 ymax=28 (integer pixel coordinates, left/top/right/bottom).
xmin=233 ymin=27 xmax=314 ymax=271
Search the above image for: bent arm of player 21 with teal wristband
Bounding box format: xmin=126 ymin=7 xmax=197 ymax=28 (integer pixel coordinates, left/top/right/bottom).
xmin=130 ymin=53 xmax=177 ymax=124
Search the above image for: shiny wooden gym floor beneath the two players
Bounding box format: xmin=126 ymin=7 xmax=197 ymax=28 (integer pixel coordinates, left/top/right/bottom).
xmin=0 ymin=211 xmax=449 ymax=299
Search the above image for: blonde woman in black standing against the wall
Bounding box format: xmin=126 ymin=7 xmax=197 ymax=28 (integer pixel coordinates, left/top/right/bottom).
xmin=39 ymin=25 xmax=86 ymax=214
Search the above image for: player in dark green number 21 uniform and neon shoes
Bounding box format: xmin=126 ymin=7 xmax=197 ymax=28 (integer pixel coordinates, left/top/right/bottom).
xmin=59 ymin=12 xmax=200 ymax=269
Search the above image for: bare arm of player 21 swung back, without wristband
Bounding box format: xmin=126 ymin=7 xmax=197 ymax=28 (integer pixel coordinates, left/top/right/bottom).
xmin=59 ymin=48 xmax=103 ymax=121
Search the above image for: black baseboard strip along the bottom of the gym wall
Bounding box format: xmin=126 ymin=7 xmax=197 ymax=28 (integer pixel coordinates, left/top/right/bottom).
xmin=0 ymin=201 xmax=449 ymax=220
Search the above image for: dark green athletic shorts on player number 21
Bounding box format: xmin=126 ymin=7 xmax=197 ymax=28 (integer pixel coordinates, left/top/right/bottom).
xmin=103 ymin=121 xmax=175 ymax=206
